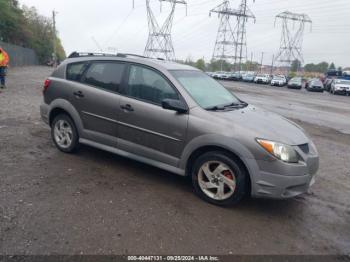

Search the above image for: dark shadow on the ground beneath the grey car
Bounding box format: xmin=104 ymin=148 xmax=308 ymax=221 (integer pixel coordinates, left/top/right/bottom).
xmin=70 ymin=143 xmax=303 ymax=216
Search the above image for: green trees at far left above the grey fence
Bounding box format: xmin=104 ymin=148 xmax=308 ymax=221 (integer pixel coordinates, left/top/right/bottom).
xmin=0 ymin=0 xmax=66 ymax=64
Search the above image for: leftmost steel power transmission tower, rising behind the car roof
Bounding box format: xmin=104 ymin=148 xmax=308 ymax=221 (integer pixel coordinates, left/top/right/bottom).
xmin=144 ymin=0 xmax=187 ymax=60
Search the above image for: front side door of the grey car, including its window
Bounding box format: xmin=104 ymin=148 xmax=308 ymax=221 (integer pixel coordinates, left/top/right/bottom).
xmin=118 ymin=64 xmax=188 ymax=166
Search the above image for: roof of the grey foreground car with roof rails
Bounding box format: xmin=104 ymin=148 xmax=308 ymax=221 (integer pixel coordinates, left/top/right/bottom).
xmin=63 ymin=55 xmax=200 ymax=71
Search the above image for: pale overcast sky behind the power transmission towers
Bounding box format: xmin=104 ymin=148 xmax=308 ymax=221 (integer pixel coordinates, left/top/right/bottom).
xmin=20 ymin=0 xmax=350 ymax=67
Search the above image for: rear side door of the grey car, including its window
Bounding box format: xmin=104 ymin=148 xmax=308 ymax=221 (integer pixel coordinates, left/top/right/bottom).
xmin=67 ymin=61 xmax=126 ymax=146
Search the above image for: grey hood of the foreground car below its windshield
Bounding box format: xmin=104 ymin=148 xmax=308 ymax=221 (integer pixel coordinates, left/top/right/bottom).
xmin=216 ymin=105 xmax=309 ymax=145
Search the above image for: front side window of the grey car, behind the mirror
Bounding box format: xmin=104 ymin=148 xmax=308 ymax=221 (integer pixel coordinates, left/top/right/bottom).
xmin=126 ymin=65 xmax=179 ymax=105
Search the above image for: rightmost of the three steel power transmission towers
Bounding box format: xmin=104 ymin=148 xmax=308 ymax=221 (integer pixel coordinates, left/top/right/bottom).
xmin=275 ymin=11 xmax=312 ymax=71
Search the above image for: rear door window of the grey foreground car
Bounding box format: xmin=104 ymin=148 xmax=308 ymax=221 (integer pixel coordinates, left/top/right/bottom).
xmin=83 ymin=62 xmax=125 ymax=92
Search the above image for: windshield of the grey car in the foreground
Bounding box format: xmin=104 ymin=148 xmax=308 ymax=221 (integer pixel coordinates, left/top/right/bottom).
xmin=170 ymin=70 xmax=242 ymax=109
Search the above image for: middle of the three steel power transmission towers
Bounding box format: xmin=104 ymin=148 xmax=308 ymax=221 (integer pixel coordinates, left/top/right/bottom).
xmin=209 ymin=0 xmax=255 ymax=70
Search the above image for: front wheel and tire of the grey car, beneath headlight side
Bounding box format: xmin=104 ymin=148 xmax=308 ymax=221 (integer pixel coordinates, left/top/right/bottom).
xmin=191 ymin=151 xmax=248 ymax=206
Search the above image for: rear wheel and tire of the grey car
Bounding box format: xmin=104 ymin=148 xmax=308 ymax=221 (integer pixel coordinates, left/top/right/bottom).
xmin=51 ymin=114 xmax=79 ymax=153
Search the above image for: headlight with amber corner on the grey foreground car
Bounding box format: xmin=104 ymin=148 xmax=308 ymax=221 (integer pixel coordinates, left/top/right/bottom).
xmin=256 ymin=139 xmax=299 ymax=163
